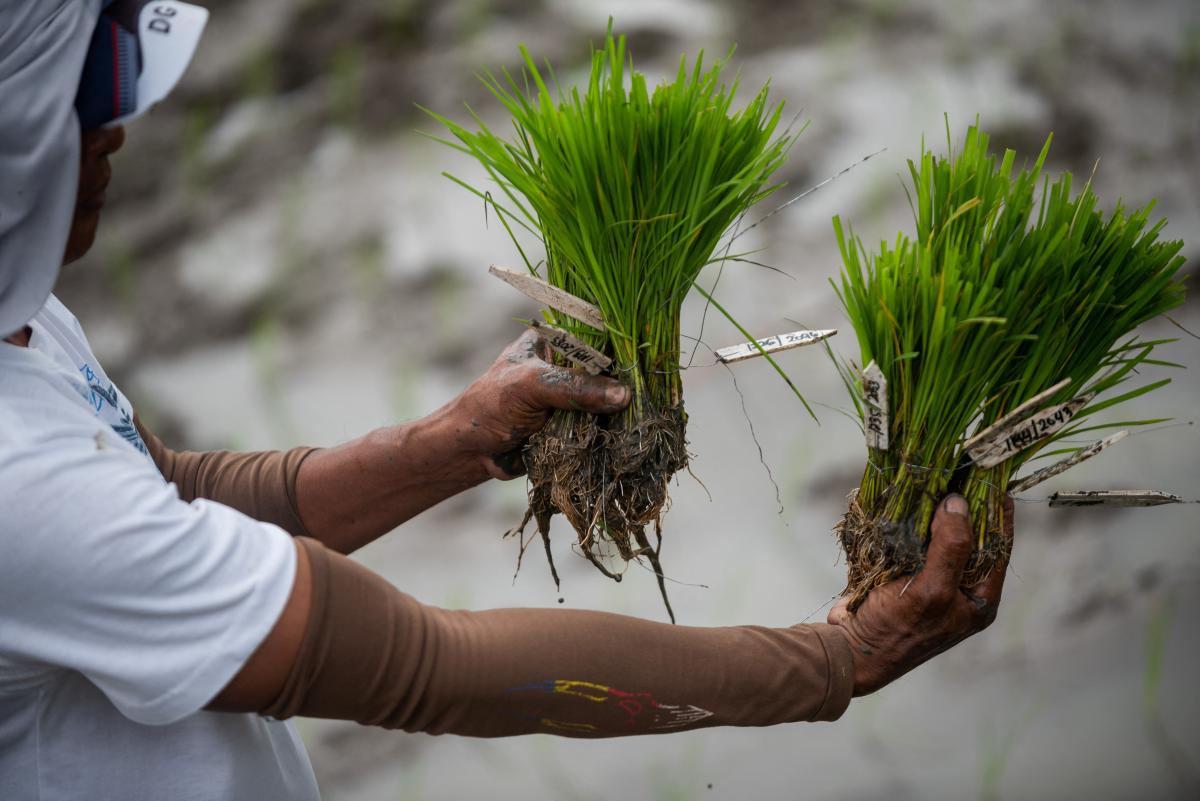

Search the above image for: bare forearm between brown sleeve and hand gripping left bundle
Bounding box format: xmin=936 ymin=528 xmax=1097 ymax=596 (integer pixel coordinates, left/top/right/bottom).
xmin=296 ymin=404 xmax=488 ymax=554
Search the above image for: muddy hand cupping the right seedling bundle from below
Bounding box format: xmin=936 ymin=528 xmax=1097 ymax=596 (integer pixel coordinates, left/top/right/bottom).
xmin=829 ymin=495 xmax=1013 ymax=695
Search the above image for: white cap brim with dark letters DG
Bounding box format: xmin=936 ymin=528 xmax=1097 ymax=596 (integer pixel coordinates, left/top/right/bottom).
xmin=109 ymin=0 xmax=209 ymax=125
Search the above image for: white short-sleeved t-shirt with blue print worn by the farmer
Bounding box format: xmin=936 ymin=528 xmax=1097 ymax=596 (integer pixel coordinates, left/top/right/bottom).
xmin=0 ymin=297 xmax=319 ymax=801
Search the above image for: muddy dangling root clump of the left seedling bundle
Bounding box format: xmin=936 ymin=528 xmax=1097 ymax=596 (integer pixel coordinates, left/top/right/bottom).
xmin=514 ymin=404 xmax=688 ymax=622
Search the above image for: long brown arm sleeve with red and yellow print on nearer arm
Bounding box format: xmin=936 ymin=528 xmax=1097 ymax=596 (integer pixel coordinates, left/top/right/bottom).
xmin=260 ymin=538 xmax=853 ymax=737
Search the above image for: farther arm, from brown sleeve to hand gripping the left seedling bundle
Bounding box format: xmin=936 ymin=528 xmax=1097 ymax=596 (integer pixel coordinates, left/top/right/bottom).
xmin=136 ymin=331 xmax=629 ymax=553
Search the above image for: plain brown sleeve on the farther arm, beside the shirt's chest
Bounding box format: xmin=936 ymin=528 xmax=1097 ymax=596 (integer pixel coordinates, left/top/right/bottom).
xmin=133 ymin=415 xmax=317 ymax=536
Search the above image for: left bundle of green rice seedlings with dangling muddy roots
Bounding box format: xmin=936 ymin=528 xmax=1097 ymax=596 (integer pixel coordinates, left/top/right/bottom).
xmin=431 ymin=25 xmax=803 ymax=609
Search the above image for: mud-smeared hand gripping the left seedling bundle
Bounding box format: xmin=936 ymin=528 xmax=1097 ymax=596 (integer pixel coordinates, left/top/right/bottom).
xmin=452 ymin=330 xmax=630 ymax=478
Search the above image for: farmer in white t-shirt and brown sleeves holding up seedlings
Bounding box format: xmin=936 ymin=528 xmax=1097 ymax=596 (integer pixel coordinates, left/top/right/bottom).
xmin=0 ymin=0 xmax=1010 ymax=801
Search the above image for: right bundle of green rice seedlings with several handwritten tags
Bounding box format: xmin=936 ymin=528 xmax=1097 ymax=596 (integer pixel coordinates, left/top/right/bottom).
xmin=834 ymin=122 xmax=1184 ymax=604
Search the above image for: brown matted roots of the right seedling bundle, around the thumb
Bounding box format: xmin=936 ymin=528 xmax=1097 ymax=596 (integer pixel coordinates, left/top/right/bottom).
xmin=834 ymin=489 xmax=1012 ymax=612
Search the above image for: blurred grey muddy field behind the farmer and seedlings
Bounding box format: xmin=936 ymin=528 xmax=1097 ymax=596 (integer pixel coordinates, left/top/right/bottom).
xmin=61 ymin=0 xmax=1200 ymax=801
